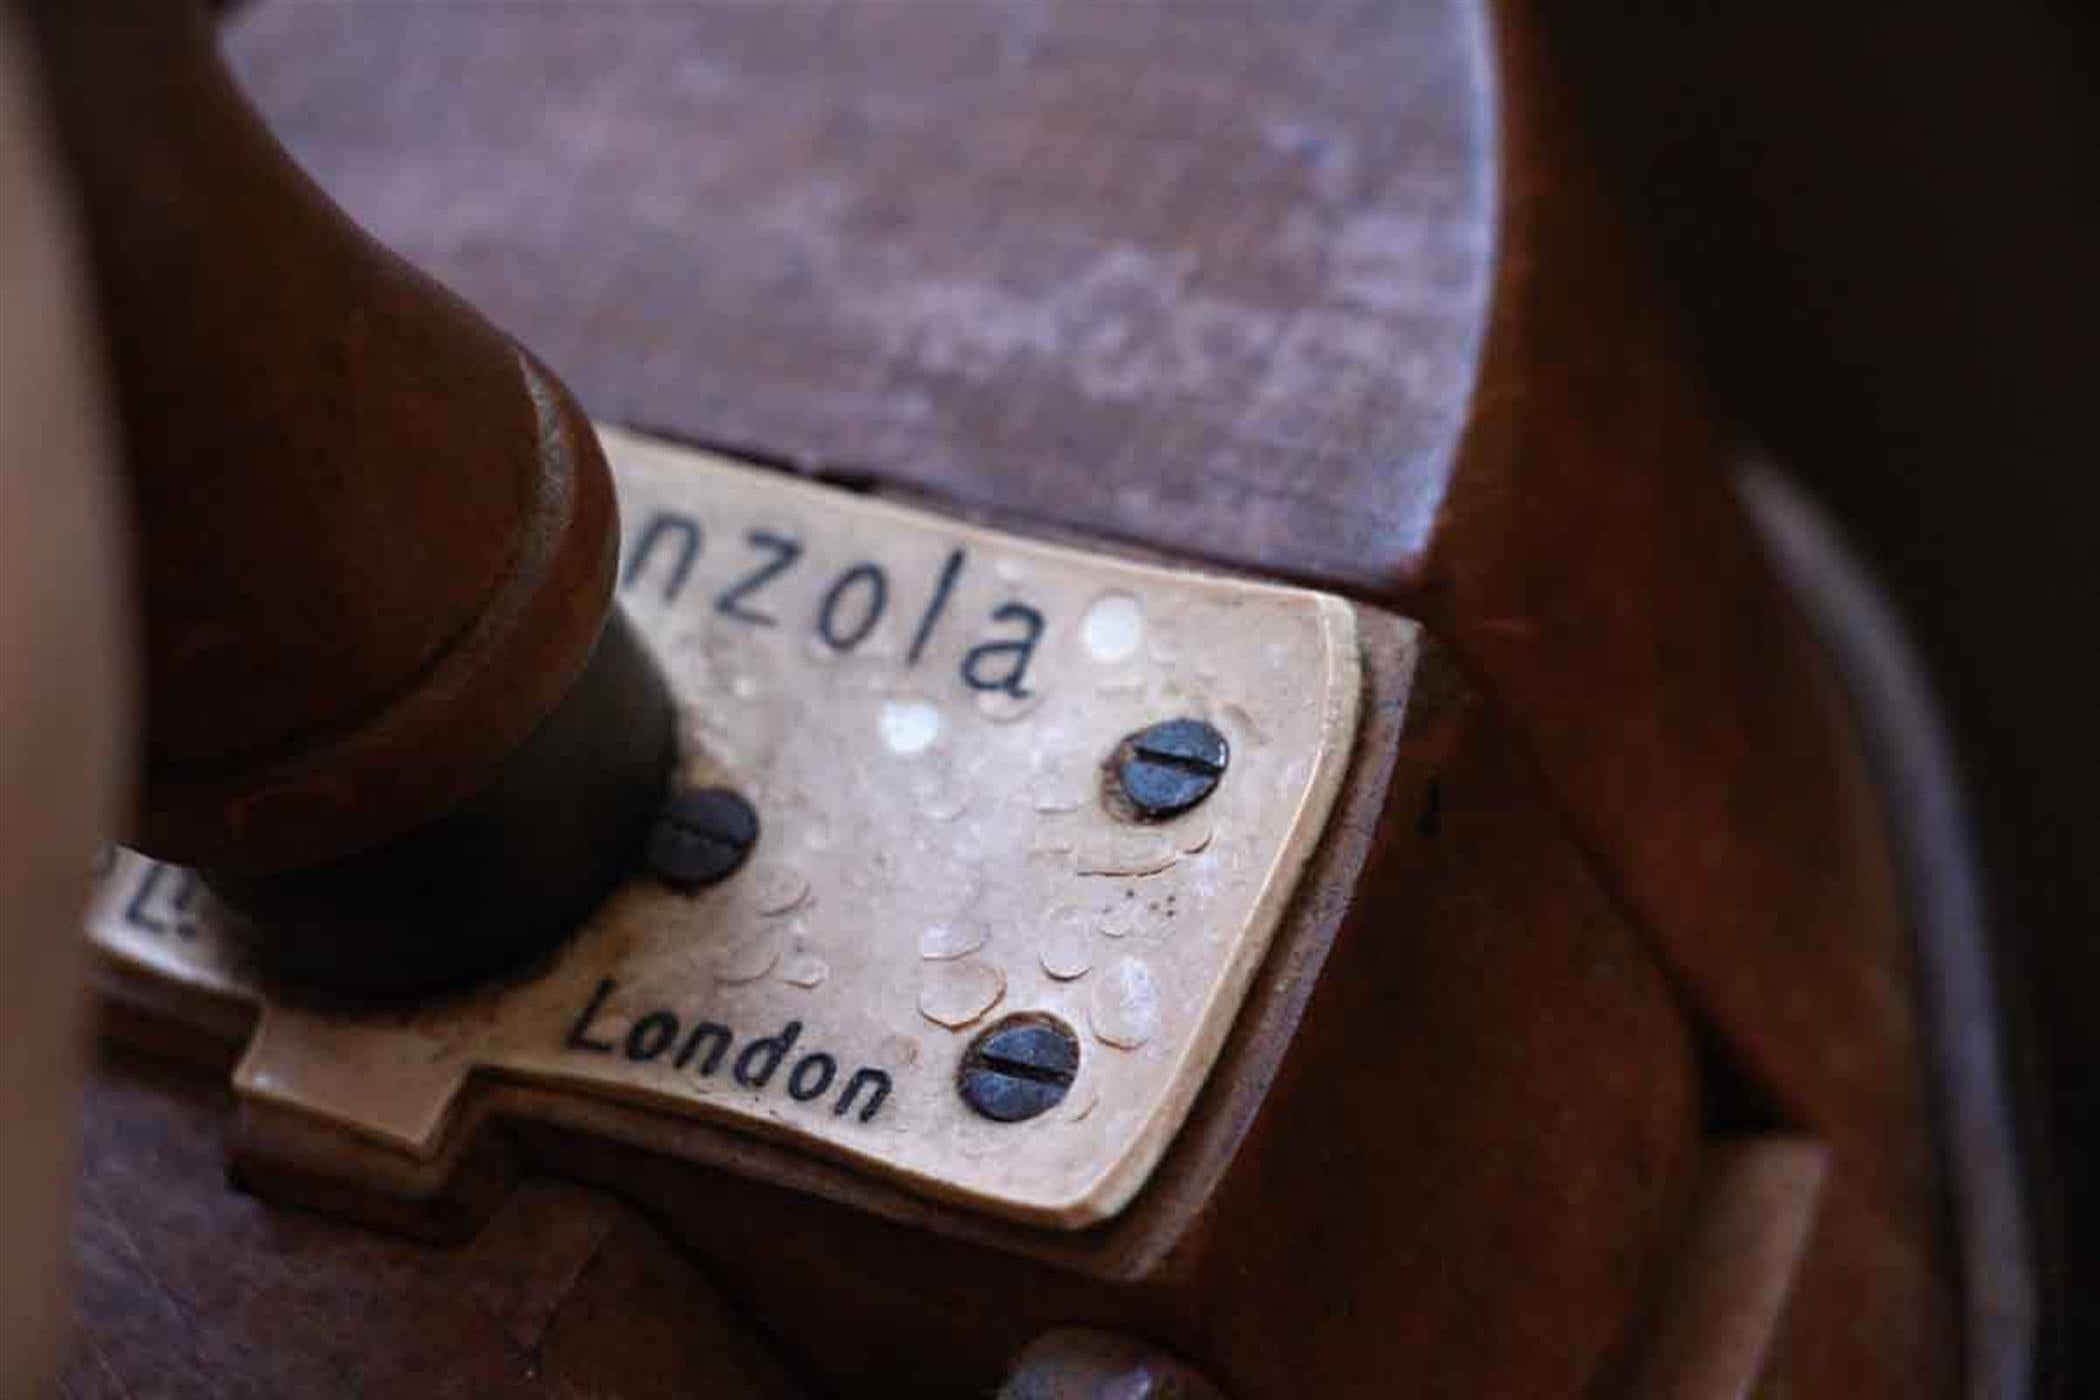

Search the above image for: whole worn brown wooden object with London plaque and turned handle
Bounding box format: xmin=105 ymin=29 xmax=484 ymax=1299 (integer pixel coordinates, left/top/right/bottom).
xmin=0 ymin=0 xmax=2022 ymax=1400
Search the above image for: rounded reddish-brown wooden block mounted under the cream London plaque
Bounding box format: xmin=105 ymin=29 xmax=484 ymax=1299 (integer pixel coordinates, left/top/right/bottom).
xmin=81 ymin=625 xmax=1785 ymax=1396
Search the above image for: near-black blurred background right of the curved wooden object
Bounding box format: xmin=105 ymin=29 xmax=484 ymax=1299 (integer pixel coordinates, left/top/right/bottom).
xmin=1548 ymin=0 xmax=2100 ymax=1394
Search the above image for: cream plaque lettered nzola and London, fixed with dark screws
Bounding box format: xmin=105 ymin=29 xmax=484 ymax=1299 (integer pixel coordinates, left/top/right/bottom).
xmin=90 ymin=428 xmax=1359 ymax=1228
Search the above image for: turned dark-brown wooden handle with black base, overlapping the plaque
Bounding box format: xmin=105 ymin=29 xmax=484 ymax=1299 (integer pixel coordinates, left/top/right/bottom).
xmin=34 ymin=0 xmax=672 ymax=989
